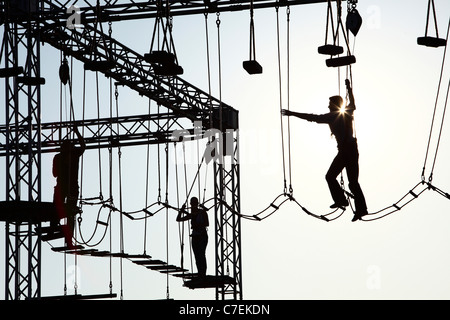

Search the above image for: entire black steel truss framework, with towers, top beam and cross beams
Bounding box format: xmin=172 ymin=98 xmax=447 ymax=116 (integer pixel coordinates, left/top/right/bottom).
xmin=0 ymin=0 xmax=326 ymax=300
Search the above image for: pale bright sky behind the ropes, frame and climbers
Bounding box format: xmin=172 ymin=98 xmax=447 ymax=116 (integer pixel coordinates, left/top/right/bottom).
xmin=0 ymin=0 xmax=450 ymax=300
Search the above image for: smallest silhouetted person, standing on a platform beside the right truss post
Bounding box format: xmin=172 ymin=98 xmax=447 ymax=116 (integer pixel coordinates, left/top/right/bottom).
xmin=177 ymin=197 xmax=209 ymax=277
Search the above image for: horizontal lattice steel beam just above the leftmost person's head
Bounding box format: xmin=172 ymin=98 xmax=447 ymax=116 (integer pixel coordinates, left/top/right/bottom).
xmin=0 ymin=113 xmax=204 ymax=157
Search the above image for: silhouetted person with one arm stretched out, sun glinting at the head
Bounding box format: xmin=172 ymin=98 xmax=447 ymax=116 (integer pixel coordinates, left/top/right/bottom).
xmin=282 ymin=79 xmax=367 ymax=221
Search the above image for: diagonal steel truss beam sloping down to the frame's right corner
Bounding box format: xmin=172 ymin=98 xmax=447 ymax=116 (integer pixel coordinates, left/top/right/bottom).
xmin=37 ymin=23 xmax=236 ymax=126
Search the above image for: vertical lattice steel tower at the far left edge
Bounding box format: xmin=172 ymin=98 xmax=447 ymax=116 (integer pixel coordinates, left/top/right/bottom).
xmin=3 ymin=2 xmax=41 ymax=300
